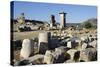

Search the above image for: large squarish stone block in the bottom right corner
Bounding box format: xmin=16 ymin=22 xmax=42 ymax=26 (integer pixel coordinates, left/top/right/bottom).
xmin=80 ymin=48 xmax=97 ymax=62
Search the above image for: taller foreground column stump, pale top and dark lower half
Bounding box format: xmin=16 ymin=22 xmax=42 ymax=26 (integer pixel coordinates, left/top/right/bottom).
xmin=38 ymin=32 xmax=50 ymax=54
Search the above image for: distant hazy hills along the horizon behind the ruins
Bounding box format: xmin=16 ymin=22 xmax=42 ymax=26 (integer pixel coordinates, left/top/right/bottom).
xmin=11 ymin=18 xmax=97 ymax=27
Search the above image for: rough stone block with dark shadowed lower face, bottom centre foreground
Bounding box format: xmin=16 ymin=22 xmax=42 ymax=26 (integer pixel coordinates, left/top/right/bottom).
xmin=52 ymin=46 xmax=70 ymax=63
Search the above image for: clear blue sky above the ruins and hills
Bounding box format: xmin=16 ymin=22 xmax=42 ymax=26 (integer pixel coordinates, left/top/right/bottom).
xmin=13 ymin=1 xmax=97 ymax=23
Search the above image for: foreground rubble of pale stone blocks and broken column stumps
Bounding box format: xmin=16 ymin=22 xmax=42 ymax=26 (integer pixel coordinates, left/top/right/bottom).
xmin=15 ymin=32 xmax=97 ymax=65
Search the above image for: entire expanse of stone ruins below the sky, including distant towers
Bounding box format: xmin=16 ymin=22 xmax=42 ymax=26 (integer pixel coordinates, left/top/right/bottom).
xmin=13 ymin=12 xmax=98 ymax=66
